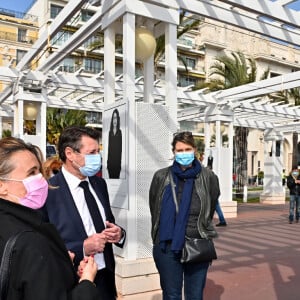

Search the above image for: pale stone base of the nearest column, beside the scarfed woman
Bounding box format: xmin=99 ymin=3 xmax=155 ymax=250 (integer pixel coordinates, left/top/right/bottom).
xmin=116 ymin=256 xmax=162 ymax=300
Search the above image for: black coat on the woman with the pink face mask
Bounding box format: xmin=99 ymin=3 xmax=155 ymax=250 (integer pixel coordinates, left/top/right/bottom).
xmin=0 ymin=199 xmax=100 ymax=300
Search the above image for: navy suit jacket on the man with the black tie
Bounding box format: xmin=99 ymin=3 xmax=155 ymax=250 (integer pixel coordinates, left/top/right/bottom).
xmin=42 ymin=172 xmax=125 ymax=273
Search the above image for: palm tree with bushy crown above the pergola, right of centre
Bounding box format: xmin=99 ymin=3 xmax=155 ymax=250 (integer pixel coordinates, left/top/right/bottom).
xmin=206 ymin=52 xmax=269 ymax=194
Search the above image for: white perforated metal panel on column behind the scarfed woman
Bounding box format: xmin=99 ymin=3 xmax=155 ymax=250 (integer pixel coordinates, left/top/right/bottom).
xmin=136 ymin=103 xmax=176 ymax=258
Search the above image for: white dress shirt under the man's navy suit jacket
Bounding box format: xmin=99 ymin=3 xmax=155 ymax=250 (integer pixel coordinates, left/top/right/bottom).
xmin=61 ymin=167 xmax=106 ymax=270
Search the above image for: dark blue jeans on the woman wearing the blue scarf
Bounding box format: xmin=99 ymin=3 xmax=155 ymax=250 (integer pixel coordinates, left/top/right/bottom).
xmin=153 ymin=245 xmax=209 ymax=300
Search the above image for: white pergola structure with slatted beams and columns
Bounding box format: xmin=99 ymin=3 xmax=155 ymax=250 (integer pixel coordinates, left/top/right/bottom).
xmin=0 ymin=0 xmax=300 ymax=299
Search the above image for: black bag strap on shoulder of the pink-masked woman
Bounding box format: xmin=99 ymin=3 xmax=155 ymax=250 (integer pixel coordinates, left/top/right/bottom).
xmin=0 ymin=230 xmax=28 ymax=300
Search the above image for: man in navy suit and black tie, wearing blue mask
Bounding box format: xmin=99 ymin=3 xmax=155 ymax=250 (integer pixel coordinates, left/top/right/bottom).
xmin=43 ymin=126 xmax=126 ymax=300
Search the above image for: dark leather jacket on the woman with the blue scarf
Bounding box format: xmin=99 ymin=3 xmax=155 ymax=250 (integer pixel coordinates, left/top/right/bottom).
xmin=149 ymin=167 xmax=220 ymax=244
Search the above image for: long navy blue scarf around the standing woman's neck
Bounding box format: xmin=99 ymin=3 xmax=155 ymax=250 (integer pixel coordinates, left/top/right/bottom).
xmin=159 ymin=159 xmax=201 ymax=253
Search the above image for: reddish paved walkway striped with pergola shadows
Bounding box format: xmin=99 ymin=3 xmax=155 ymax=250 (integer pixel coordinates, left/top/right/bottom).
xmin=204 ymin=203 xmax=300 ymax=300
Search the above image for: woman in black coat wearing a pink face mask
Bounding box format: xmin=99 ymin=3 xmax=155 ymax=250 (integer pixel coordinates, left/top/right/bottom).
xmin=0 ymin=137 xmax=101 ymax=300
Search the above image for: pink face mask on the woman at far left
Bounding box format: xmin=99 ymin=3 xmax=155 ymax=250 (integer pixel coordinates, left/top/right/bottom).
xmin=5 ymin=173 xmax=48 ymax=209
